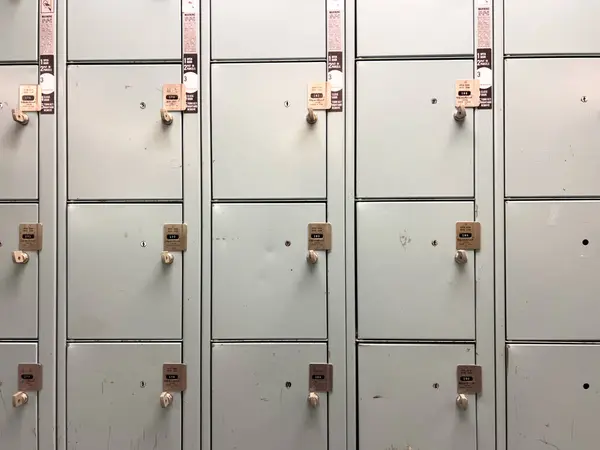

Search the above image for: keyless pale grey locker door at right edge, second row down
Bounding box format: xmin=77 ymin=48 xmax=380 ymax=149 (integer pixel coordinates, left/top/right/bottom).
xmin=504 ymin=58 xmax=600 ymax=197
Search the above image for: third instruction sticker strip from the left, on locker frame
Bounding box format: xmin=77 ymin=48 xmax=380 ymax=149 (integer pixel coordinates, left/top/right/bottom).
xmin=327 ymin=0 xmax=344 ymax=112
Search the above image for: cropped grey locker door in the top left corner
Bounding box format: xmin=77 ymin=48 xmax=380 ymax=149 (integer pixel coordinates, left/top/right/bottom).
xmin=0 ymin=0 xmax=40 ymax=62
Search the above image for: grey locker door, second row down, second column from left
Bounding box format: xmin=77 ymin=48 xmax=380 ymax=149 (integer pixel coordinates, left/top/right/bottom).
xmin=67 ymin=64 xmax=182 ymax=200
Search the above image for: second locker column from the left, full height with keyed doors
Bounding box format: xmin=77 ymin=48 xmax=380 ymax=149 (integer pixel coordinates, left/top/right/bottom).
xmin=57 ymin=0 xmax=200 ymax=450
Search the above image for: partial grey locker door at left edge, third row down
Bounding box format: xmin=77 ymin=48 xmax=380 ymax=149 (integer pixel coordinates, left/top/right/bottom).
xmin=0 ymin=204 xmax=38 ymax=338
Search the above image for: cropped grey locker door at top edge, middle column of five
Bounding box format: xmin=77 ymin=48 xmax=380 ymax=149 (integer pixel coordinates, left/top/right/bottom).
xmin=211 ymin=0 xmax=326 ymax=59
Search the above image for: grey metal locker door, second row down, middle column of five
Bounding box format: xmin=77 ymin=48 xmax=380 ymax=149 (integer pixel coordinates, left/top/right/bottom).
xmin=212 ymin=62 xmax=327 ymax=199
